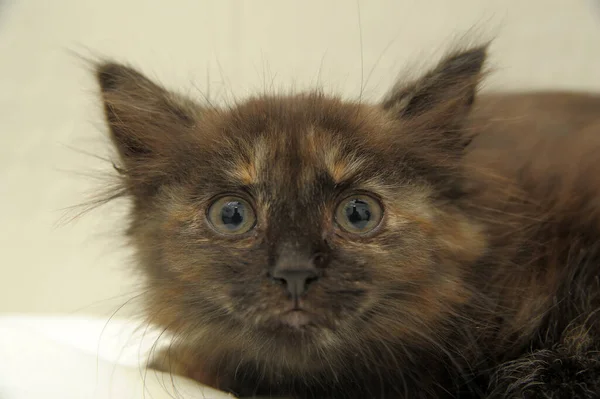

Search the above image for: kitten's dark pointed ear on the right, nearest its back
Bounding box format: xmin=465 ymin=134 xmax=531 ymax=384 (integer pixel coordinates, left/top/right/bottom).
xmin=383 ymin=44 xmax=488 ymax=134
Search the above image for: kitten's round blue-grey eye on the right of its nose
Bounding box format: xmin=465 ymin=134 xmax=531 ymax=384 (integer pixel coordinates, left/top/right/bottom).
xmin=335 ymin=195 xmax=383 ymax=234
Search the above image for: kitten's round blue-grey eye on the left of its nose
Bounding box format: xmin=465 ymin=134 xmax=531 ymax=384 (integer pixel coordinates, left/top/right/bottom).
xmin=208 ymin=197 xmax=256 ymax=234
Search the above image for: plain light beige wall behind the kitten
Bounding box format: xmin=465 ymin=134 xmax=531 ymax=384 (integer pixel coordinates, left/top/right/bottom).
xmin=0 ymin=0 xmax=600 ymax=314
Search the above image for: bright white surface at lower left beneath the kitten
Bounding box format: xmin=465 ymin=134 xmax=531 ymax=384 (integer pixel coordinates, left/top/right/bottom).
xmin=0 ymin=316 xmax=232 ymax=399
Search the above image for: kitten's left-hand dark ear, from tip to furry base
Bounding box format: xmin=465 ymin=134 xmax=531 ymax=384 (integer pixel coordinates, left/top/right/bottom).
xmin=95 ymin=62 xmax=202 ymax=197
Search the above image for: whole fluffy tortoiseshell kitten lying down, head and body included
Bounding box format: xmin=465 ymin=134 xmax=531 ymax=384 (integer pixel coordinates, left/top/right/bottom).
xmin=96 ymin=46 xmax=600 ymax=398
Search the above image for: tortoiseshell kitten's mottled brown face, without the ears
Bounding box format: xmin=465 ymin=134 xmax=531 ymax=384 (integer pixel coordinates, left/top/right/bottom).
xmin=152 ymin=97 xmax=458 ymax=338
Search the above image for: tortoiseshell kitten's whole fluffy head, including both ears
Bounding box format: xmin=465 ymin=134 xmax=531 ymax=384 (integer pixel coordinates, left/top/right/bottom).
xmin=97 ymin=47 xmax=486 ymax=369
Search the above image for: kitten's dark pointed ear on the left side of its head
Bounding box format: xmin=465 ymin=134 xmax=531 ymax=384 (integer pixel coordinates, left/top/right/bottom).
xmin=96 ymin=62 xmax=199 ymax=168
